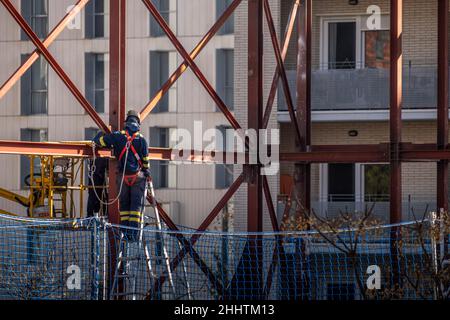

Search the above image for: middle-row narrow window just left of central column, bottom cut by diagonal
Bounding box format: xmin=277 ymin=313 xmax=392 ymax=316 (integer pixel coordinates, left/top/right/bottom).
xmin=216 ymin=49 xmax=234 ymax=110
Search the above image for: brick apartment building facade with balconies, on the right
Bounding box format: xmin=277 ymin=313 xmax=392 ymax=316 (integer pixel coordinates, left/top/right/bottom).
xmin=235 ymin=0 xmax=450 ymax=229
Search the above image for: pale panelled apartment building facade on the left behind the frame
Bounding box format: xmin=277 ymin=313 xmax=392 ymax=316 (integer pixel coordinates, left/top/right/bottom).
xmin=0 ymin=0 xmax=234 ymax=227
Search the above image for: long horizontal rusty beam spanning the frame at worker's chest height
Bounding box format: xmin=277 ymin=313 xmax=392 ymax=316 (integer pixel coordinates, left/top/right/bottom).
xmin=6 ymin=140 xmax=450 ymax=164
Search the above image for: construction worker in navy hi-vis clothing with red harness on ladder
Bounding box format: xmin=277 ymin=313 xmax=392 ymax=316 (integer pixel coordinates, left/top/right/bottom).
xmin=94 ymin=110 xmax=150 ymax=241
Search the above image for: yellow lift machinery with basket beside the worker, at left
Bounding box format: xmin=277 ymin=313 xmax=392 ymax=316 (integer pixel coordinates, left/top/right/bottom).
xmin=0 ymin=155 xmax=99 ymax=218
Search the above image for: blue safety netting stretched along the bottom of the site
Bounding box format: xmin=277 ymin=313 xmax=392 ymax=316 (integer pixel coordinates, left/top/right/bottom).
xmin=0 ymin=215 xmax=450 ymax=300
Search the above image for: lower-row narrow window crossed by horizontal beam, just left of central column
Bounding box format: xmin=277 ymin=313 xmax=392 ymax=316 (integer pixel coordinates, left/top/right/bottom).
xmin=215 ymin=126 xmax=234 ymax=189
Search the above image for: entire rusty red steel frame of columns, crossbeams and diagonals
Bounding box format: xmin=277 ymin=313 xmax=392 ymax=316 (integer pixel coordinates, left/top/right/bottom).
xmin=0 ymin=0 xmax=450 ymax=293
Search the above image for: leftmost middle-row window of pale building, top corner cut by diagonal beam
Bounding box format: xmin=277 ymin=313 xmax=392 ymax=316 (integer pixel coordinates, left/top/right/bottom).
xmin=20 ymin=54 xmax=48 ymax=115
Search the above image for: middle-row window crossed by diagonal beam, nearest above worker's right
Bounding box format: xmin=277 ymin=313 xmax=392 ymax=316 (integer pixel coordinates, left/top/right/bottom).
xmin=150 ymin=51 xmax=173 ymax=113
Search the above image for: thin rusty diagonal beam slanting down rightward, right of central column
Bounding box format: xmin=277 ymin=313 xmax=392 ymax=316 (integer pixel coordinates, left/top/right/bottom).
xmin=261 ymin=0 xmax=301 ymax=140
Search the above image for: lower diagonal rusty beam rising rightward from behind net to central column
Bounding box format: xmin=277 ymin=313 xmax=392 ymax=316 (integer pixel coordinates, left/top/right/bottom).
xmin=149 ymin=174 xmax=244 ymax=296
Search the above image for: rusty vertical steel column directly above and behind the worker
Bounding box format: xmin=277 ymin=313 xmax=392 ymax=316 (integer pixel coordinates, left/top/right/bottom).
xmin=108 ymin=0 xmax=126 ymax=223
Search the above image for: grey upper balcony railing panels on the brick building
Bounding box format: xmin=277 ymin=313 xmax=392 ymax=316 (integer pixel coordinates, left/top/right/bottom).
xmin=278 ymin=63 xmax=437 ymax=111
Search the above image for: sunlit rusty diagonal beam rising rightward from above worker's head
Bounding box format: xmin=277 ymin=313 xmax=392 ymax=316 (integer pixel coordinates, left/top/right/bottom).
xmin=140 ymin=0 xmax=242 ymax=121
